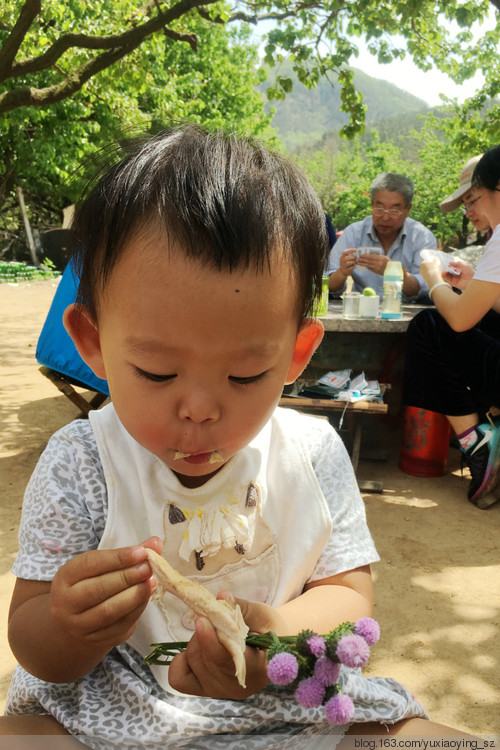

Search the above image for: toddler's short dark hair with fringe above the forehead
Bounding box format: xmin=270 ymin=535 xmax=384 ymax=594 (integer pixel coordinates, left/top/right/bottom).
xmin=72 ymin=125 xmax=329 ymax=319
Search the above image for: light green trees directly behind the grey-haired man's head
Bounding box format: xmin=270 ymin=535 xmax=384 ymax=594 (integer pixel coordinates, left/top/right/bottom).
xmin=295 ymin=112 xmax=492 ymax=247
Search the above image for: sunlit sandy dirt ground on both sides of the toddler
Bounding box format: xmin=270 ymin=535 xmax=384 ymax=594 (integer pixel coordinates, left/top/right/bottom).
xmin=0 ymin=281 xmax=500 ymax=735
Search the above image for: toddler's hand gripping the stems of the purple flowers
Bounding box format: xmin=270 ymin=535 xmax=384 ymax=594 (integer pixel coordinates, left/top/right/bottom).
xmin=168 ymin=592 xmax=275 ymax=700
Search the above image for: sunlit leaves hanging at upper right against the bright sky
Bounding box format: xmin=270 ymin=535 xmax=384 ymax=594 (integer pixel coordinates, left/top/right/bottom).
xmin=260 ymin=0 xmax=500 ymax=137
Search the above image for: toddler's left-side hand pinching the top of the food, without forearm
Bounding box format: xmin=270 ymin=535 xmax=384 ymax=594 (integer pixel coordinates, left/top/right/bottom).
xmin=50 ymin=537 xmax=161 ymax=648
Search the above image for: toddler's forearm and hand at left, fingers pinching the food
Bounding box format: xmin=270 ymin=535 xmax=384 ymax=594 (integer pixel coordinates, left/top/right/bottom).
xmin=9 ymin=537 xmax=161 ymax=682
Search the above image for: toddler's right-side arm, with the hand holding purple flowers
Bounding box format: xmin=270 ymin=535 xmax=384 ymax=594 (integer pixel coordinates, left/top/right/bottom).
xmin=169 ymin=566 xmax=373 ymax=700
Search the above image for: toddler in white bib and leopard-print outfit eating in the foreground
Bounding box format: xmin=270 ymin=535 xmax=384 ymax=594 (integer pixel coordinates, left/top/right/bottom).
xmin=0 ymin=126 xmax=466 ymax=750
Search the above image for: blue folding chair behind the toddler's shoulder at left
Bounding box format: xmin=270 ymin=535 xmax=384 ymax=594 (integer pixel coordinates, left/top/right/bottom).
xmin=36 ymin=261 xmax=109 ymax=417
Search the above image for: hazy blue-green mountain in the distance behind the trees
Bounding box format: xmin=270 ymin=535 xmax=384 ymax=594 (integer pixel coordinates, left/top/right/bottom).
xmin=262 ymin=63 xmax=430 ymax=145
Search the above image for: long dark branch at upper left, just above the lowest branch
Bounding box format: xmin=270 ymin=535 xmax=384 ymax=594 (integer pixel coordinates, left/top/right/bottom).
xmin=0 ymin=0 xmax=211 ymax=82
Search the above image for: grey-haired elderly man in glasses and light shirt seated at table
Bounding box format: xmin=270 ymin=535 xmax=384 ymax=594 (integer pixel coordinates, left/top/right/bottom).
xmin=326 ymin=172 xmax=437 ymax=300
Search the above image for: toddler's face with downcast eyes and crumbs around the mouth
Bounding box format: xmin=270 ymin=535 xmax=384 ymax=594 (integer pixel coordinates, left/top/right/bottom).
xmin=90 ymin=237 xmax=321 ymax=486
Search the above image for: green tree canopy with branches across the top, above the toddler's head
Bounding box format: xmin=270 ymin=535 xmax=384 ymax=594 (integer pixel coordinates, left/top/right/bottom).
xmin=0 ymin=0 xmax=500 ymax=256
